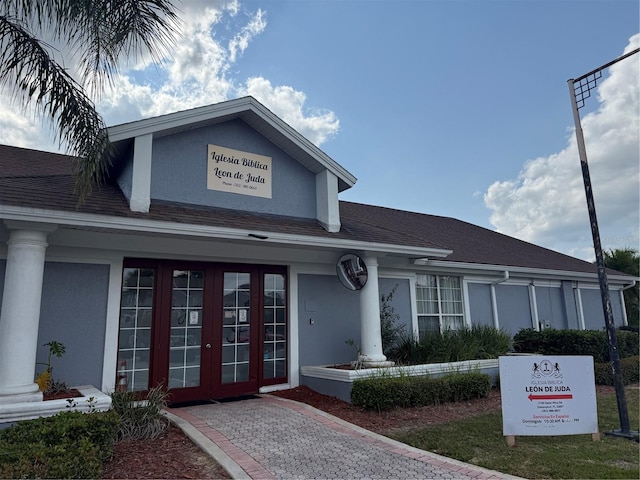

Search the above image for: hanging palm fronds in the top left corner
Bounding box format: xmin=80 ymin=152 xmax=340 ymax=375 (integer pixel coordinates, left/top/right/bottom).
xmin=0 ymin=0 xmax=178 ymax=202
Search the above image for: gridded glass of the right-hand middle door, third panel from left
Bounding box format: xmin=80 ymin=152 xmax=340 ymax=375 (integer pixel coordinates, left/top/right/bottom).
xmin=221 ymin=272 xmax=251 ymax=384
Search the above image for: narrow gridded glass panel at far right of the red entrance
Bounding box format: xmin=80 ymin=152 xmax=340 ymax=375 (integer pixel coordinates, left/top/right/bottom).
xmin=262 ymin=273 xmax=287 ymax=380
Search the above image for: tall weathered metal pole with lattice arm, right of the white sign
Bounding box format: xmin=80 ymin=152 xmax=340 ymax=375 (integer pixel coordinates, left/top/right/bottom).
xmin=567 ymin=48 xmax=640 ymax=439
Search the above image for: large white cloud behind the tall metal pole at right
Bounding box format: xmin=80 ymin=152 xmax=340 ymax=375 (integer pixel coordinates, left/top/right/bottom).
xmin=484 ymin=34 xmax=640 ymax=260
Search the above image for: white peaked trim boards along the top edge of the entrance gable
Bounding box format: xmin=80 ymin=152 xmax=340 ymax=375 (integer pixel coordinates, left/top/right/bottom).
xmin=107 ymin=97 xmax=357 ymax=187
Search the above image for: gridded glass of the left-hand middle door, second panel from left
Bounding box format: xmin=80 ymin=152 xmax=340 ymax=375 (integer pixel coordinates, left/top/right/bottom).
xmin=169 ymin=270 xmax=204 ymax=388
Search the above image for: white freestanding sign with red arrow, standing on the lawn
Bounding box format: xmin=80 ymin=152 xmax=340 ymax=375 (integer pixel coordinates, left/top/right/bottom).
xmin=500 ymin=355 xmax=598 ymax=436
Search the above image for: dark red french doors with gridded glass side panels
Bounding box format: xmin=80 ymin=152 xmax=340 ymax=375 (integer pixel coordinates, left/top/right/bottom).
xmin=119 ymin=261 xmax=287 ymax=403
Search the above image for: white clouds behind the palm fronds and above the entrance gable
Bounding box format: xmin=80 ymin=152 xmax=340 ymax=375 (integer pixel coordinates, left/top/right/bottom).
xmin=0 ymin=0 xmax=339 ymax=151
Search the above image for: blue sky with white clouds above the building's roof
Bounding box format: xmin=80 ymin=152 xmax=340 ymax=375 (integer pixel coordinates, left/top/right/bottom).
xmin=0 ymin=0 xmax=640 ymax=259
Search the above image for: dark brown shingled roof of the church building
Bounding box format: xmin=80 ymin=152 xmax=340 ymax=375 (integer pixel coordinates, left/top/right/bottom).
xmin=0 ymin=145 xmax=632 ymax=274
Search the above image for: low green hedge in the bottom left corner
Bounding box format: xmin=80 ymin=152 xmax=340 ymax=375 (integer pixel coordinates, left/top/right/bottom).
xmin=0 ymin=411 xmax=120 ymax=478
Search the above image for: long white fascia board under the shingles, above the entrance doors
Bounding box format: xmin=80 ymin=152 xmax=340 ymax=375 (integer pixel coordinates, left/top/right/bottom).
xmin=0 ymin=206 xmax=452 ymax=257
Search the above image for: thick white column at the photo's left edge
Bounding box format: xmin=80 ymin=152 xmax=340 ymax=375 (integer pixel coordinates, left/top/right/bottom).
xmin=0 ymin=222 xmax=55 ymax=403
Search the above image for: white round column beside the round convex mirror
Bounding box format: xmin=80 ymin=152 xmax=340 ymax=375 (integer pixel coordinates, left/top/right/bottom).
xmin=360 ymin=256 xmax=393 ymax=366
